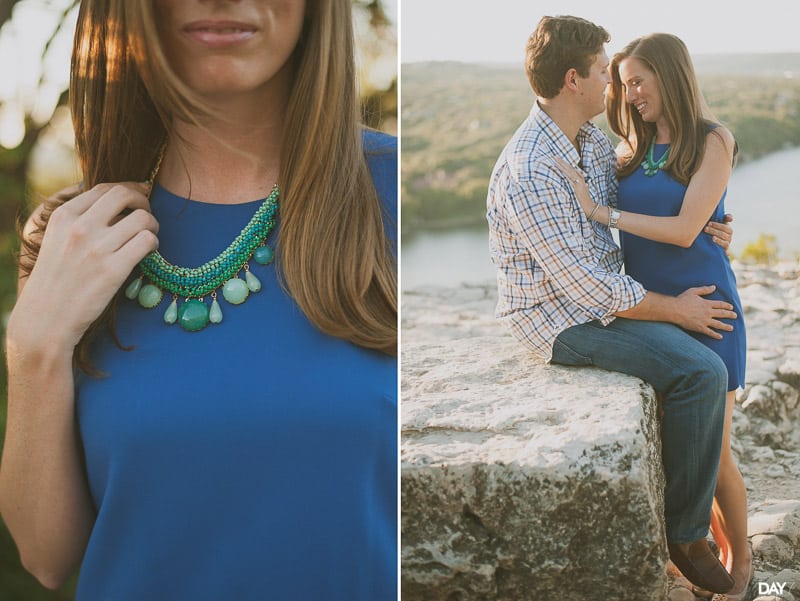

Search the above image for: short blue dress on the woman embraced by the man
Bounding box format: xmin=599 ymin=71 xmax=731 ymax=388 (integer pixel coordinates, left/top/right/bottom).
xmin=617 ymin=144 xmax=747 ymax=390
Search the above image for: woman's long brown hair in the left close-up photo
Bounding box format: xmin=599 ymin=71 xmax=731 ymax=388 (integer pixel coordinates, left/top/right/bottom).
xmin=20 ymin=0 xmax=397 ymax=373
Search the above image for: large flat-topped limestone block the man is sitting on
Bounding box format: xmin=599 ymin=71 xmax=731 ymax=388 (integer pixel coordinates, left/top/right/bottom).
xmin=401 ymin=336 xmax=667 ymax=601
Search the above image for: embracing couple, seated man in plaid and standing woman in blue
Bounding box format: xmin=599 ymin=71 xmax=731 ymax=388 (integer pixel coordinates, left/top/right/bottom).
xmin=487 ymin=16 xmax=752 ymax=601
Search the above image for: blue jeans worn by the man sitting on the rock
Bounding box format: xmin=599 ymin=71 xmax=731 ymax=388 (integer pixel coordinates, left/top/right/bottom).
xmin=552 ymin=317 xmax=728 ymax=543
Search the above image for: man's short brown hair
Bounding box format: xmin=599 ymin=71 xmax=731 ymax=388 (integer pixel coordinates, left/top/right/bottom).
xmin=525 ymin=16 xmax=610 ymax=98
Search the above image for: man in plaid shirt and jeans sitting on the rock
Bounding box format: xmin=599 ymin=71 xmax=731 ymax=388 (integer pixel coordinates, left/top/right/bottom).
xmin=487 ymin=17 xmax=735 ymax=593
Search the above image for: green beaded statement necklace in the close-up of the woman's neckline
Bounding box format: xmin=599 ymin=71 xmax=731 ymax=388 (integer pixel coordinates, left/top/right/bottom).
xmin=125 ymin=150 xmax=279 ymax=332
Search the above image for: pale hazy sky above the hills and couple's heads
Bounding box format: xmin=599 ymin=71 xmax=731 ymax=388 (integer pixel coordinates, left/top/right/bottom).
xmin=400 ymin=0 xmax=800 ymax=62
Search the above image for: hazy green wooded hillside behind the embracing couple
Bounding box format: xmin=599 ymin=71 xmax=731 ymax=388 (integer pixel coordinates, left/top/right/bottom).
xmin=401 ymin=53 xmax=800 ymax=231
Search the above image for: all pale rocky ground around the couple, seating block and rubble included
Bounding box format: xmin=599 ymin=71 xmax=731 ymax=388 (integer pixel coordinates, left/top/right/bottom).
xmin=402 ymin=263 xmax=800 ymax=601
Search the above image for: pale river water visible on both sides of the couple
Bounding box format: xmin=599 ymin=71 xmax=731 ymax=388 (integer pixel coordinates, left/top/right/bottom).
xmin=400 ymin=148 xmax=800 ymax=290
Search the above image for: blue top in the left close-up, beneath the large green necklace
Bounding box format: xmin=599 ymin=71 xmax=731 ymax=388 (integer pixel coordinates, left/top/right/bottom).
xmin=76 ymin=133 xmax=397 ymax=601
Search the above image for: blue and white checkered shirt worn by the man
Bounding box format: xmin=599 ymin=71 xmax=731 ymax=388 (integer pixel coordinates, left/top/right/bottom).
xmin=486 ymin=103 xmax=645 ymax=361
